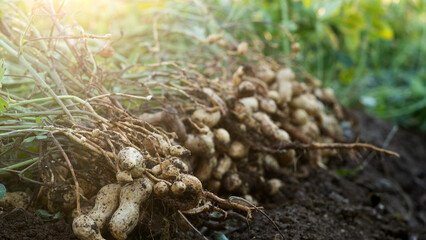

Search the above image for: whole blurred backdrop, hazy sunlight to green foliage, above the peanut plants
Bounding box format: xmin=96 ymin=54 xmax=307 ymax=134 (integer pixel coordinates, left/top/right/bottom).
xmin=0 ymin=0 xmax=426 ymax=133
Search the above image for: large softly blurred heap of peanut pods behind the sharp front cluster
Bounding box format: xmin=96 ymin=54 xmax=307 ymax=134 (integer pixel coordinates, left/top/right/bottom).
xmin=140 ymin=61 xmax=343 ymax=202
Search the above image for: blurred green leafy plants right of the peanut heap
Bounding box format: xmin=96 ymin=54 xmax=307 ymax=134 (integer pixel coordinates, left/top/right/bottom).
xmin=243 ymin=0 xmax=426 ymax=132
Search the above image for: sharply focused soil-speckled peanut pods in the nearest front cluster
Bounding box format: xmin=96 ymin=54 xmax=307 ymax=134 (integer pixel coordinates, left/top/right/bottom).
xmin=73 ymin=145 xmax=202 ymax=240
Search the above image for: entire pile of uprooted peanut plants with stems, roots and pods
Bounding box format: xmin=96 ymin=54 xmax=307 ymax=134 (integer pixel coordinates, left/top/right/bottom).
xmin=0 ymin=1 xmax=393 ymax=239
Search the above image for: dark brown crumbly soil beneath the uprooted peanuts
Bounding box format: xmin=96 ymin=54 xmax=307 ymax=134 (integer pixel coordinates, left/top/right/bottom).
xmin=0 ymin=112 xmax=426 ymax=240
